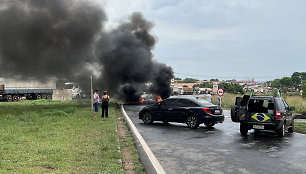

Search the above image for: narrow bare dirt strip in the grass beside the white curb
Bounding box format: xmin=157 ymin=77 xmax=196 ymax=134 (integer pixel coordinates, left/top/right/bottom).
xmin=117 ymin=119 xmax=135 ymax=174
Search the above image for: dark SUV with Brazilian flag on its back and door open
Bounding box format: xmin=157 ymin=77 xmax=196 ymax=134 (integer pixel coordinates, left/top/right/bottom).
xmin=231 ymin=95 xmax=295 ymax=137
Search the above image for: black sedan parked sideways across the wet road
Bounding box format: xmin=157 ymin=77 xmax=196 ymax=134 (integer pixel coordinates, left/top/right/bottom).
xmin=139 ymin=96 xmax=224 ymax=128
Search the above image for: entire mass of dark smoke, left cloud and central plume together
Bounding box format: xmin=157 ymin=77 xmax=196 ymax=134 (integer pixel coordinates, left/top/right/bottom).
xmin=0 ymin=0 xmax=173 ymax=101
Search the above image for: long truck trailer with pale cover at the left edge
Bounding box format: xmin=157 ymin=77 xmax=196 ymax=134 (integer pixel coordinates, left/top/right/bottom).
xmin=0 ymin=78 xmax=56 ymax=102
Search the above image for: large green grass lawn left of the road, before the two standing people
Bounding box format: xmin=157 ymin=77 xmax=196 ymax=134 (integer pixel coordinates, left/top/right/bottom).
xmin=0 ymin=100 xmax=143 ymax=173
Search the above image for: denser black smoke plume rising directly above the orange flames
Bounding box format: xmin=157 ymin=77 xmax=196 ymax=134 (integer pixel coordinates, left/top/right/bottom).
xmin=97 ymin=13 xmax=173 ymax=100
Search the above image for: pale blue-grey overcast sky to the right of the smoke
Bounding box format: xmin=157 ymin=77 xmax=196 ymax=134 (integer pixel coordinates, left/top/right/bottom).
xmin=102 ymin=0 xmax=306 ymax=81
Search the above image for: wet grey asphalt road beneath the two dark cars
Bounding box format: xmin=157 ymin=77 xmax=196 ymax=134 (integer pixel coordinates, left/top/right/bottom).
xmin=124 ymin=105 xmax=306 ymax=174
